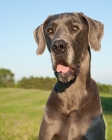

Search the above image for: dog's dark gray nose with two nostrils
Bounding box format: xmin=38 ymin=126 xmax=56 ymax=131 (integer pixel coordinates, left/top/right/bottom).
xmin=52 ymin=40 xmax=67 ymax=53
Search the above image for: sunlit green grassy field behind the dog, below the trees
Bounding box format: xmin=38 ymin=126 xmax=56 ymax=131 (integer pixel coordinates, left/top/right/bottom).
xmin=0 ymin=88 xmax=112 ymax=140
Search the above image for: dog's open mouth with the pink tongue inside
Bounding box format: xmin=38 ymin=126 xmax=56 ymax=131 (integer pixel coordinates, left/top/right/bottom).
xmin=56 ymin=60 xmax=74 ymax=74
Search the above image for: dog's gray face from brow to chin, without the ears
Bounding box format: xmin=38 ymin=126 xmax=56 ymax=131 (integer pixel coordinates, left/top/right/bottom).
xmin=44 ymin=14 xmax=88 ymax=82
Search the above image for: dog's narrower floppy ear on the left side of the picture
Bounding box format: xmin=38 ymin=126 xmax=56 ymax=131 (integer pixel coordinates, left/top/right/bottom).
xmin=34 ymin=24 xmax=46 ymax=55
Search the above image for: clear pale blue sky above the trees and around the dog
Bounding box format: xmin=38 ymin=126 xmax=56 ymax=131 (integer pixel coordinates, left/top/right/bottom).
xmin=0 ymin=0 xmax=112 ymax=85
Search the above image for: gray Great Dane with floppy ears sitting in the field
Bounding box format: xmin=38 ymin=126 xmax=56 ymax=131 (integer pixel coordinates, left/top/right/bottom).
xmin=34 ymin=13 xmax=105 ymax=140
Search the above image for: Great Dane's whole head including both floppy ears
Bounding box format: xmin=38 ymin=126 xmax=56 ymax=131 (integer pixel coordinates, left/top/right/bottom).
xmin=34 ymin=13 xmax=103 ymax=82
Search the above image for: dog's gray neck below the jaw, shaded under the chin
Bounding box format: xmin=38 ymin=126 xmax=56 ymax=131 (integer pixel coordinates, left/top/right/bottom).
xmin=54 ymin=49 xmax=91 ymax=93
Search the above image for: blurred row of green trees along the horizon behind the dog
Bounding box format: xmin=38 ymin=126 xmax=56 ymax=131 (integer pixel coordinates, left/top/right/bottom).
xmin=0 ymin=68 xmax=112 ymax=92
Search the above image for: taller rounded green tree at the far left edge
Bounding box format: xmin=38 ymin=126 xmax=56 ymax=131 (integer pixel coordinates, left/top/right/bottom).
xmin=0 ymin=68 xmax=14 ymax=87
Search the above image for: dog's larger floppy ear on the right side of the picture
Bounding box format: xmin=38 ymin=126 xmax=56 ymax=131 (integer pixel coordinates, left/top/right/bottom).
xmin=80 ymin=13 xmax=104 ymax=51
